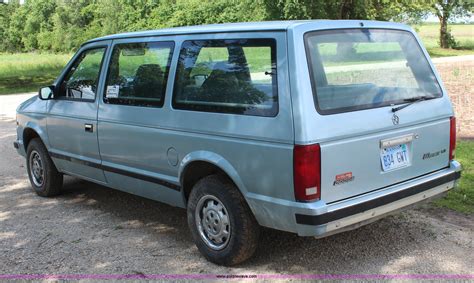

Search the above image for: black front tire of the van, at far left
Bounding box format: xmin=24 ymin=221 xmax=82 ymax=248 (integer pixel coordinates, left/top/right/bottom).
xmin=26 ymin=138 xmax=63 ymax=197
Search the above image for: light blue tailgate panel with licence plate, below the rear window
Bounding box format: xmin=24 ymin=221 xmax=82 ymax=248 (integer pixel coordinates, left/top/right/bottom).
xmin=321 ymin=118 xmax=449 ymax=202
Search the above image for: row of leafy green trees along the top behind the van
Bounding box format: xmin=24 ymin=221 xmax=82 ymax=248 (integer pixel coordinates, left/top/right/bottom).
xmin=0 ymin=0 xmax=472 ymax=52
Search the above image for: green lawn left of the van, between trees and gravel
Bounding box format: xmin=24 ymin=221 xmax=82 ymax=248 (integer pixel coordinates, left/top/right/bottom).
xmin=0 ymin=53 xmax=72 ymax=94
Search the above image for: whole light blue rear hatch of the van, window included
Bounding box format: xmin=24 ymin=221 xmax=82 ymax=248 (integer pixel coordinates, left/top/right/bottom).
xmin=304 ymin=28 xmax=451 ymax=203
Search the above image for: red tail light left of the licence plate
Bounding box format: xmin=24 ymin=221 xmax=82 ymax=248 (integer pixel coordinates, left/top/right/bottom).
xmin=293 ymin=144 xmax=321 ymax=202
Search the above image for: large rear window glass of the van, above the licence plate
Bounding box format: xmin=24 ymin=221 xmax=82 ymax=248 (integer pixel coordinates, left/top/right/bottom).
xmin=305 ymin=29 xmax=441 ymax=114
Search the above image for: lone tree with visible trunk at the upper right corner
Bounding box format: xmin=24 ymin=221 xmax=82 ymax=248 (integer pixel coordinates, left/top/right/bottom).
xmin=432 ymin=0 xmax=472 ymax=48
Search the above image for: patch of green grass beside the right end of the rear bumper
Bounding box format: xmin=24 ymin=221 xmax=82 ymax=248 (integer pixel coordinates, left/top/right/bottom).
xmin=435 ymin=141 xmax=474 ymax=214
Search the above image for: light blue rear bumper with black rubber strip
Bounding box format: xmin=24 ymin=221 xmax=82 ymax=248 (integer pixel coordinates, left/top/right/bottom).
xmin=249 ymin=161 xmax=461 ymax=237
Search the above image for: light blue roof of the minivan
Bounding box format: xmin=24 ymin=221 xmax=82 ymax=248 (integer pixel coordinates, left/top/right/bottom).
xmin=84 ymin=20 xmax=407 ymax=44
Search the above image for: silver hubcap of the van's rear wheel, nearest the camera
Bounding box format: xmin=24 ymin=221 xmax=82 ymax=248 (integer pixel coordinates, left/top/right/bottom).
xmin=195 ymin=195 xmax=230 ymax=250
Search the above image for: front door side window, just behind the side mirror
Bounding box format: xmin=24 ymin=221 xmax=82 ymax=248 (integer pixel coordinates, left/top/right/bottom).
xmin=57 ymin=47 xmax=105 ymax=101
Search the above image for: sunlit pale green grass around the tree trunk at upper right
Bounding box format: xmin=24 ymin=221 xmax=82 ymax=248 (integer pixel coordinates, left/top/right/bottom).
xmin=415 ymin=24 xmax=474 ymax=57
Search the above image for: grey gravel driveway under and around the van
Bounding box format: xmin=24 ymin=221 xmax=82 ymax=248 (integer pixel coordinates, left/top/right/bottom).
xmin=0 ymin=92 xmax=474 ymax=274
